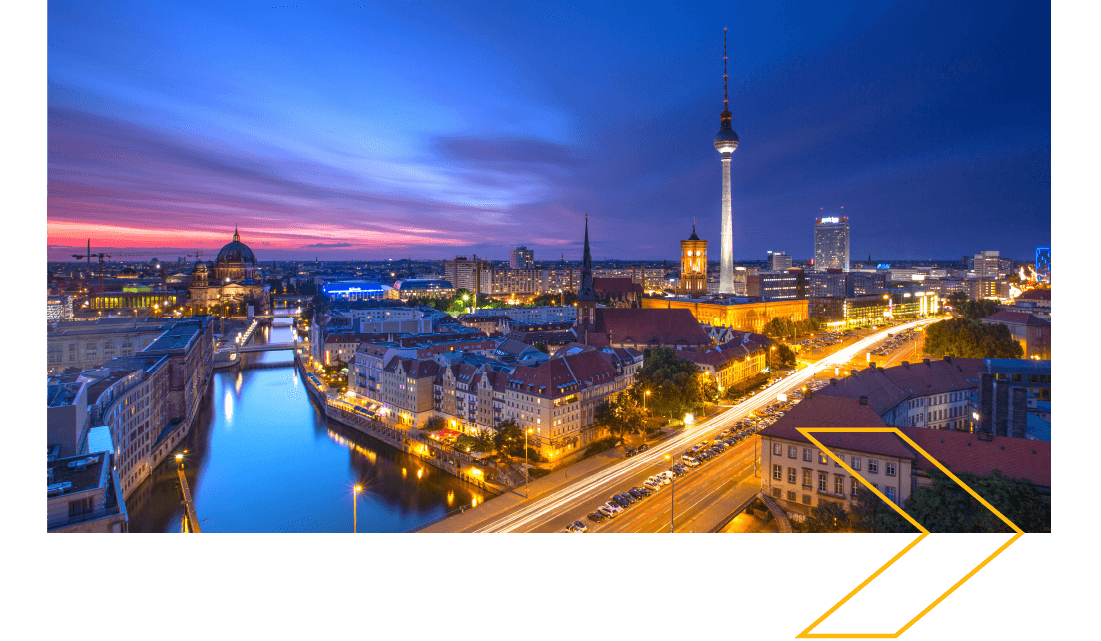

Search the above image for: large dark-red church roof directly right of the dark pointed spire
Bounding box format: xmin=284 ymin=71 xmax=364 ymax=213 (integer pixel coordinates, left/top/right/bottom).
xmin=590 ymin=307 xmax=711 ymax=347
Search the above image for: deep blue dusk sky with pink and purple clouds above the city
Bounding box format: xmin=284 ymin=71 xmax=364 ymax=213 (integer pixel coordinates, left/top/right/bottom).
xmin=47 ymin=2 xmax=1050 ymax=261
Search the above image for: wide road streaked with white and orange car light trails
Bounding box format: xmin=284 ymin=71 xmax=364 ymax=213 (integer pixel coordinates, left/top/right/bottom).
xmin=473 ymin=318 xmax=936 ymax=532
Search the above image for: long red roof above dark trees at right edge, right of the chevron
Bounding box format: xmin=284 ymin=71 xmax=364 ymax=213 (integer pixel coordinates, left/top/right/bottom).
xmin=902 ymin=427 xmax=1051 ymax=488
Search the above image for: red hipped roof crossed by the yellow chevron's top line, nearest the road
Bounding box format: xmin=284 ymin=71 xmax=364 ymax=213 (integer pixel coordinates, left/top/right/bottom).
xmin=760 ymin=394 xmax=916 ymax=459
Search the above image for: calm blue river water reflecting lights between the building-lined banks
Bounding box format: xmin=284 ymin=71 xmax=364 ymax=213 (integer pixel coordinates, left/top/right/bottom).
xmin=127 ymin=318 xmax=484 ymax=532
